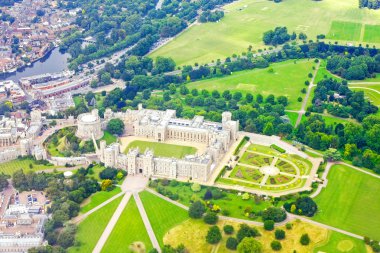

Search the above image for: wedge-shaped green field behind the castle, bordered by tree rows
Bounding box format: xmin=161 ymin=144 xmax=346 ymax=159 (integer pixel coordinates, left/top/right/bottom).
xmin=188 ymin=60 xmax=315 ymax=110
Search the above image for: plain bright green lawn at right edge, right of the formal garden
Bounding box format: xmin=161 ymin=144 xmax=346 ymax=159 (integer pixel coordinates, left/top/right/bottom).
xmin=314 ymin=165 xmax=380 ymax=240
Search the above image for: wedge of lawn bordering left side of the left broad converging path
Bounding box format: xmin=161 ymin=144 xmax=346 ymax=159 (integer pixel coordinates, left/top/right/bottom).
xmin=68 ymin=197 xmax=122 ymax=253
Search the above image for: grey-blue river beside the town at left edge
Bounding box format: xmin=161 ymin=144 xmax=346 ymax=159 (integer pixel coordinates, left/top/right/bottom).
xmin=0 ymin=48 xmax=70 ymax=82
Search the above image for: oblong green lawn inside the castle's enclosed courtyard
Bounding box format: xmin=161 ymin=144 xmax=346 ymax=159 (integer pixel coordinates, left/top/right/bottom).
xmin=124 ymin=141 xmax=197 ymax=158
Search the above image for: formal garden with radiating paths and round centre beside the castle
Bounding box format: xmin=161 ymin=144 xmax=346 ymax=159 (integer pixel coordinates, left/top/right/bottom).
xmin=216 ymin=144 xmax=312 ymax=192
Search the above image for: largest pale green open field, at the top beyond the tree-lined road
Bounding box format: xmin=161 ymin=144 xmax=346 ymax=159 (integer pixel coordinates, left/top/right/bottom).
xmin=151 ymin=0 xmax=380 ymax=65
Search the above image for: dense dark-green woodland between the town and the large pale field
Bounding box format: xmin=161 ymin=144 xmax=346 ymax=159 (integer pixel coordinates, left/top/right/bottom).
xmin=60 ymin=0 xmax=232 ymax=69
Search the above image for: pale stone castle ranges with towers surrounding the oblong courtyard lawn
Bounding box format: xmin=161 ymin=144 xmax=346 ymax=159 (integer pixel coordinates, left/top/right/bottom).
xmin=94 ymin=105 xmax=239 ymax=182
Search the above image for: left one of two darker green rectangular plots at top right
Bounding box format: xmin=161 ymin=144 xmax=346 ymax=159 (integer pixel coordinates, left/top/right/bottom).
xmin=326 ymin=21 xmax=362 ymax=41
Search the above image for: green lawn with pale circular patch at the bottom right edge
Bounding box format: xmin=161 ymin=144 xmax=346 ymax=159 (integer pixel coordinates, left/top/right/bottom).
xmin=314 ymin=230 xmax=367 ymax=253
